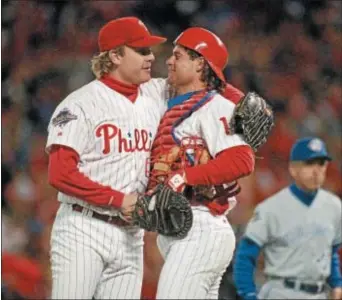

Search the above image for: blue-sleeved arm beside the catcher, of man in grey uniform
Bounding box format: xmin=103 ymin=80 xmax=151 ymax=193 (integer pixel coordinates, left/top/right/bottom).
xmin=233 ymin=238 xmax=261 ymax=299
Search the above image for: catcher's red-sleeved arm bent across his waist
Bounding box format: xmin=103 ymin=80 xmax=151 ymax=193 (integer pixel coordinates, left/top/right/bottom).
xmin=185 ymin=145 xmax=255 ymax=185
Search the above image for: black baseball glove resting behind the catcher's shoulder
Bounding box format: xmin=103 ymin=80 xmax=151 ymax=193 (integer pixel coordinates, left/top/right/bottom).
xmin=230 ymin=92 xmax=274 ymax=151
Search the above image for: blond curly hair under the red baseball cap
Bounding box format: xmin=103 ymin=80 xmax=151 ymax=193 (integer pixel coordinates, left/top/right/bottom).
xmin=91 ymin=47 xmax=124 ymax=79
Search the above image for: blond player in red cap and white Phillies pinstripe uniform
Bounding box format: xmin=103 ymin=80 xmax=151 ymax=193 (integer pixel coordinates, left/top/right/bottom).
xmin=46 ymin=17 xmax=166 ymax=299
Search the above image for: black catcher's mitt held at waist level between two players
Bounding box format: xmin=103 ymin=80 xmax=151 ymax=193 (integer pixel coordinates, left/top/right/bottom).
xmin=132 ymin=184 xmax=193 ymax=238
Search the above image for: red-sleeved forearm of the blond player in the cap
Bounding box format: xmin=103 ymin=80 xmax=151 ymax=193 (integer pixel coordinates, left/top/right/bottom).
xmin=49 ymin=146 xmax=124 ymax=207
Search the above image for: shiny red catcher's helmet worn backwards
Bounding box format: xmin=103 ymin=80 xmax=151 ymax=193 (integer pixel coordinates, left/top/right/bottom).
xmin=174 ymin=27 xmax=229 ymax=81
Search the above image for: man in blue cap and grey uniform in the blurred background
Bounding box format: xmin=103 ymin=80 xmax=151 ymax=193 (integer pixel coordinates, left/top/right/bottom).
xmin=233 ymin=138 xmax=342 ymax=299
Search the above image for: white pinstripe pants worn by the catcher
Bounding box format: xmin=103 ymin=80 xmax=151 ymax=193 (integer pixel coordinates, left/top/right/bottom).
xmin=157 ymin=208 xmax=235 ymax=299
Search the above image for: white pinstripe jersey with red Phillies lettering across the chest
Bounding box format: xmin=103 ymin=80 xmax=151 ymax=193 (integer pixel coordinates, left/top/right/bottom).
xmin=46 ymin=79 xmax=167 ymax=215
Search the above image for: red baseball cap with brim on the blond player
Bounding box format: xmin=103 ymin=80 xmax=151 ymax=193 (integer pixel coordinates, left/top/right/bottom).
xmin=98 ymin=17 xmax=166 ymax=51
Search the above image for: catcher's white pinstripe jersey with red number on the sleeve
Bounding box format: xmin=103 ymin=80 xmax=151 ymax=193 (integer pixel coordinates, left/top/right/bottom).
xmin=174 ymin=94 xmax=248 ymax=213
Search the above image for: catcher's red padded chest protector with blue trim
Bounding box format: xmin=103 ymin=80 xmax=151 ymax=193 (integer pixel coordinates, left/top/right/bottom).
xmin=148 ymin=91 xmax=238 ymax=214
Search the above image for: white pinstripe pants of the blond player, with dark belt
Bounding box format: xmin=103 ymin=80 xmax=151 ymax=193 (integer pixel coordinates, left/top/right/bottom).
xmin=51 ymin=204 xmax=143 ymax=299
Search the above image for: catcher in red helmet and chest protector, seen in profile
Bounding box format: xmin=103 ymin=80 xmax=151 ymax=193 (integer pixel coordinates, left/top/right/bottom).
xmin=149 ymin=27 xmax=264 ymax=299
